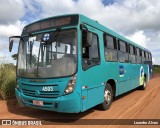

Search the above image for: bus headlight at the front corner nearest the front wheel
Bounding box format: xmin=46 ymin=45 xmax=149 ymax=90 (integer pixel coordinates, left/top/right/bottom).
xmin=64 ymin=76 xmax=76 ymax=94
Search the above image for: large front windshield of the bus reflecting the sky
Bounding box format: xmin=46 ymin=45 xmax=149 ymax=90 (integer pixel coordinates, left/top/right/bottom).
xmin=17 ymin=30 xmax=77 ymax=78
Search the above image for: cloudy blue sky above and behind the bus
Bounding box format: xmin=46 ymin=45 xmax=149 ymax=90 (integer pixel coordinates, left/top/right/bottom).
xmin=0 ymin=0 xmax=160 ymax=65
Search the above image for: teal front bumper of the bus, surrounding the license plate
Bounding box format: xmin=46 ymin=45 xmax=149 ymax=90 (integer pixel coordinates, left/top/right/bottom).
xmin=15 ymin=88 xmax=81 ymax=113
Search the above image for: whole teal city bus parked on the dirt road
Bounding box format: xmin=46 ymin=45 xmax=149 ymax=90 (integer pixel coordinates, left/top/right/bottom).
xmin=9 ymin=14 xmax=152 ymax=113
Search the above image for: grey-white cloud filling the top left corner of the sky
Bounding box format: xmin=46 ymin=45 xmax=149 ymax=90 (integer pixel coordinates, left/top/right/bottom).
xmin=0 ymin=0 xmax=25 ymax=24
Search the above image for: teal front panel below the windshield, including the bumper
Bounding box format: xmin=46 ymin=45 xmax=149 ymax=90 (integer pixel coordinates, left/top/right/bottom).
xmin=15 ymin=78 xmax=81 ymax=113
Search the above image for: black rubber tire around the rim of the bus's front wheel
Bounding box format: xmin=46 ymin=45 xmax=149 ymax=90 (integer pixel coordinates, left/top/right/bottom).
xmin=98 ymin=83 xmax=114 ymax=110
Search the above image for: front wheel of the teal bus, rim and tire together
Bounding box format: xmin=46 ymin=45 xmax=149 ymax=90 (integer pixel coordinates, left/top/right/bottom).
xmin=98 ymin=83 xmax=113 ymax=110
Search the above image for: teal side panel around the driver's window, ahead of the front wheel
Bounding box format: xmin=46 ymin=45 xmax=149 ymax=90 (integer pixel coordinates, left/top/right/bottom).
xmin=78 ymin=25 xmax=105 ymax=111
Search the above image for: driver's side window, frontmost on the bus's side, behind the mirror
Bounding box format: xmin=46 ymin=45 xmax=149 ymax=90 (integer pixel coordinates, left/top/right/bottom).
xmin=82 ymin=31 xmax=100 ymax=70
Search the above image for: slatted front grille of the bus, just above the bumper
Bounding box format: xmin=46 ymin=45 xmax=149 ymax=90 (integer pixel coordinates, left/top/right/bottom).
xmin=22 ymin=89 xmax=59 ymax=98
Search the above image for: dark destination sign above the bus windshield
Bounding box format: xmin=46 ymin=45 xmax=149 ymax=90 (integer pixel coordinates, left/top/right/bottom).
xmin=22 ymin=15 xmax=79 ymax=35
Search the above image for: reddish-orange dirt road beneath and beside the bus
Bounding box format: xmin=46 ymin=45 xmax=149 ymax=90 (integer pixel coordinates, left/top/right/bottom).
xmin=0 ymin=75 xmax=160 ymax=128
